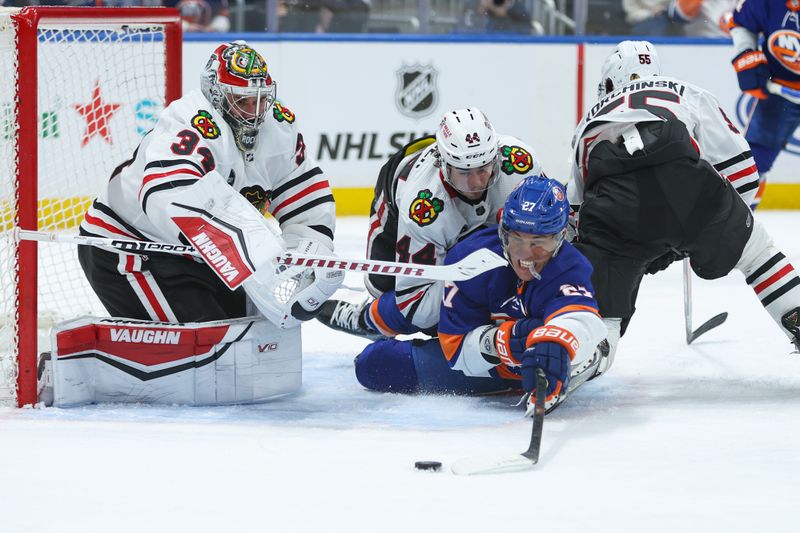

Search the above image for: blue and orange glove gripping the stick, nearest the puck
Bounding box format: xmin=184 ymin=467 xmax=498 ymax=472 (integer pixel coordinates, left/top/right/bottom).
xmin=522 ymin=326 xmax=578 ymax=401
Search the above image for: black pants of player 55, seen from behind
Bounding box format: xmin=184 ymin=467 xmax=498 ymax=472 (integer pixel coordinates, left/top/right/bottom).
xmin=576 ymin=121 xmax=753 ymax=333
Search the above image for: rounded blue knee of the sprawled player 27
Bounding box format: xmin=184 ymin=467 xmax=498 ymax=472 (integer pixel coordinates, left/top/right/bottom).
xmin=355 ymin=339 xmax=418 ymax=392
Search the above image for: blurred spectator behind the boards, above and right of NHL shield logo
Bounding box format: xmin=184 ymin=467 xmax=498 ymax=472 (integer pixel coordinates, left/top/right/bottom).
xmin=458 ymin=0 xmax=531 ymax=34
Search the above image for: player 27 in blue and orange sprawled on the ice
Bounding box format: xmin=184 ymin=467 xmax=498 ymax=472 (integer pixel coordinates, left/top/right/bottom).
xmin=355 ymin=176 xmax=609 ymax=407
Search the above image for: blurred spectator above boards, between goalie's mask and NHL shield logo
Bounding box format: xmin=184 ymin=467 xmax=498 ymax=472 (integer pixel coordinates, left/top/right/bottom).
xmin=279 ymin=0 xmax=370 ymax=33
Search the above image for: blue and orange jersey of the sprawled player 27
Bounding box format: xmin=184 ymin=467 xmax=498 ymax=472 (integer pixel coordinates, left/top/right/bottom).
xmin=439 ymin=227 xmax=606 ymax=379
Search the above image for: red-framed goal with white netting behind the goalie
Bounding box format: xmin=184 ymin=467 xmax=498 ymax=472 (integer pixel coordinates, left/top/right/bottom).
xmin=0 ymin=7 xmax=182 ymax=407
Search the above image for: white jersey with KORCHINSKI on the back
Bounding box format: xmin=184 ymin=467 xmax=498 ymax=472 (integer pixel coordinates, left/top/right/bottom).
xmin=568 ymin=76 xmax=758 ymax=205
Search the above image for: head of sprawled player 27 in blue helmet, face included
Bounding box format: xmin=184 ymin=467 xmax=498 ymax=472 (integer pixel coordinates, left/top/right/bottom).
xmin=498 ymin=176 xmax=569 ymax=281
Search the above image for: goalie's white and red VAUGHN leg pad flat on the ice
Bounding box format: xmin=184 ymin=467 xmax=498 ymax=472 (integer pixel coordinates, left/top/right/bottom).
xmin=40 ymin=317 xmax=302 ymax=407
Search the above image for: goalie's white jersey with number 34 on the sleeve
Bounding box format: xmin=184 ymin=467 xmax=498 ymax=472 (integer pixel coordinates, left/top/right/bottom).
xmin=81 ymin=90 xmax=336 ymax=249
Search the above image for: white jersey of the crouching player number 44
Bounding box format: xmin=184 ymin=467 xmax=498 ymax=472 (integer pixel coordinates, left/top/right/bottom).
xmin=367 ymin=135 xmax=542 ymax=329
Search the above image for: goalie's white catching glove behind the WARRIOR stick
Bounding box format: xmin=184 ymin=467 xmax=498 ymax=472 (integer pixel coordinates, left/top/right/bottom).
xmin=287 ymin=239 xmax=344 ymax=321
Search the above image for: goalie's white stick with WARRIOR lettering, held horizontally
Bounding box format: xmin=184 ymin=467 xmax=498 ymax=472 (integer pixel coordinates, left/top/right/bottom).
xmin=14 ymin=228 xmax=508 ymax=281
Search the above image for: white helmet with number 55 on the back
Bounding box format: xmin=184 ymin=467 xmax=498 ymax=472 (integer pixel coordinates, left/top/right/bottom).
xmin=597 ymin=41 xmax=661 ymax=98
